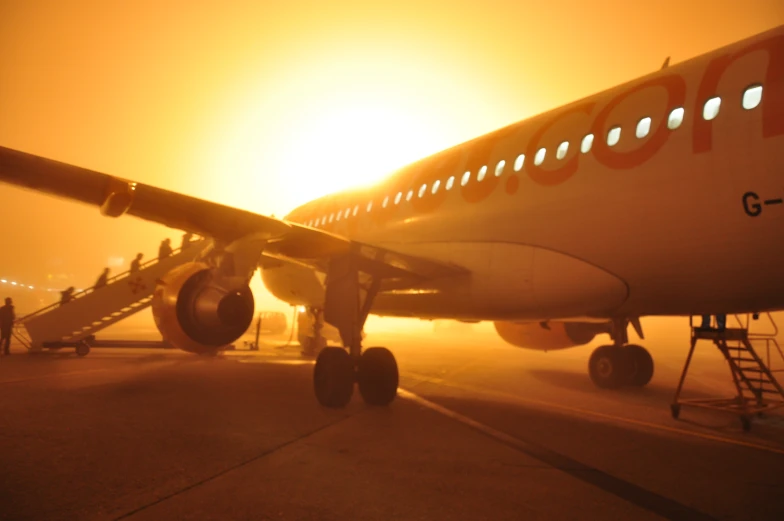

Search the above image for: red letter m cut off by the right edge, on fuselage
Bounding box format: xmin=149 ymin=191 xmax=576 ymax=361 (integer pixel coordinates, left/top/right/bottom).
xmin=692 ymin=34 xmax=784 ymax=154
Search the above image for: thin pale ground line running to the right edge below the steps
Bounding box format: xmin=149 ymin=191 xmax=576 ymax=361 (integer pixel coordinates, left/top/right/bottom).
xmin=404 ymin=375 xmax=784 ymax=455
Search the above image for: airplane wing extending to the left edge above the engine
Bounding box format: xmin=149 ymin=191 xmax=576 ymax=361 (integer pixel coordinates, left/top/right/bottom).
xmin=0 ymin=147 xmax=465 ymax=281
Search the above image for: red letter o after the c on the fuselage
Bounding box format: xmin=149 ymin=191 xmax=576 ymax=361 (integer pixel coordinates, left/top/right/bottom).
xmin=591 ymin=75 xmax=686 ymax=169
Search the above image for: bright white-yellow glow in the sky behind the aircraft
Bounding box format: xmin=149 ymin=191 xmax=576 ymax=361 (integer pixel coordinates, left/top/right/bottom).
xmin=199 ymin=42 xmax=502 ymax=216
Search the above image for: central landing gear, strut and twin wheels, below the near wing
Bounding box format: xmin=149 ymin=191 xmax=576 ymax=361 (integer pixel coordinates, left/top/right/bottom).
xmin=313 ymin=251 xmax=399 ymax=408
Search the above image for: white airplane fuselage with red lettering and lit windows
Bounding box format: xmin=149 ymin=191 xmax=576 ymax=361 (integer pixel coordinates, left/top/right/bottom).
xmin=263 ymin=28 xmax=784 ymax=320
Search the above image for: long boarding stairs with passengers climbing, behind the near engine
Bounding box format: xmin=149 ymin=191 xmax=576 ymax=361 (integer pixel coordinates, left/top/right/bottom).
xmin=13 ymin=240 xmax=207 ymax=356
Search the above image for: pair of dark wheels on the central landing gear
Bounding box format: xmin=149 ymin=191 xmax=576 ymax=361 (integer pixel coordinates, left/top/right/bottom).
xmin=313 ymin=347 xmax=399 ymax=408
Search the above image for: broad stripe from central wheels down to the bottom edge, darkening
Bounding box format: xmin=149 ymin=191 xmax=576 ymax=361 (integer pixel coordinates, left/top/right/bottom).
xmin=397 ymin=389 xmax=715 ymax=521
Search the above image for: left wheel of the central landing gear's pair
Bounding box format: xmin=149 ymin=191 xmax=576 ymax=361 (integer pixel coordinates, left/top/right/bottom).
xmin=313 ymin=347 xmax=354 ymax=408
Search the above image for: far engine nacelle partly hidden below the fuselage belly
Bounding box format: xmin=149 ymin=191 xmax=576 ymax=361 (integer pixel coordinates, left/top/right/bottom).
xmin=494 ymin=322 xmax=610 ymax=351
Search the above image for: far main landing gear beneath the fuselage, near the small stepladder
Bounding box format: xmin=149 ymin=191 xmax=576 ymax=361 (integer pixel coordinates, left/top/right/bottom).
xmin=588 ymin=320 xmax=653 ymax=389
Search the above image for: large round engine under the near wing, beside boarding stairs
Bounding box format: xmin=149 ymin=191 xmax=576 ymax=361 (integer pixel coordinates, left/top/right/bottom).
xmin=152 ymin=262 xmax=254 ymax=354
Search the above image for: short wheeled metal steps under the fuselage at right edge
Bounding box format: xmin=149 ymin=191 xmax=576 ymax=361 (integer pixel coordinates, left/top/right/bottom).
xmin=670 ymin=313 xmax=784 ymax=431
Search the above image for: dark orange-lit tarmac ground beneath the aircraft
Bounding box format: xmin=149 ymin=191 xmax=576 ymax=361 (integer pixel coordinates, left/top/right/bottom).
xmin=0 ymin=318 xmax=784 ymax=521
